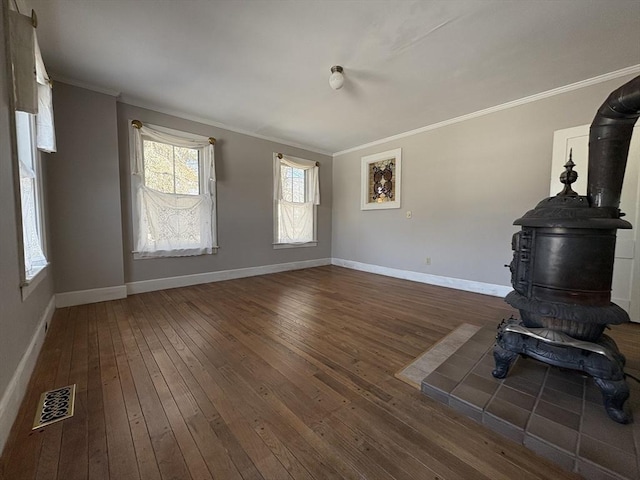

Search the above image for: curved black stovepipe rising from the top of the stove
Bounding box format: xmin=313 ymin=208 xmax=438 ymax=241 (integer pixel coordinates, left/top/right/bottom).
xmin=587 ymin=76 xmax=640 ymax=210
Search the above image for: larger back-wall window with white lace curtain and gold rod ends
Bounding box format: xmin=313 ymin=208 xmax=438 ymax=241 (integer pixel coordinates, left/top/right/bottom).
xmin=131 ymin=120 xmax=218 ymax=258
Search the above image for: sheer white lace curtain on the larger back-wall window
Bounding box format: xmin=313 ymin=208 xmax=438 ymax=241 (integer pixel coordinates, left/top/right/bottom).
xmin=131 ymin=125 xmax=218 ymax=258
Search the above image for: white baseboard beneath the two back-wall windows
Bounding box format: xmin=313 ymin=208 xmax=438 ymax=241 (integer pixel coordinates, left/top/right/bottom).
xmin=127 ymin=258 xmax=331 ymax=295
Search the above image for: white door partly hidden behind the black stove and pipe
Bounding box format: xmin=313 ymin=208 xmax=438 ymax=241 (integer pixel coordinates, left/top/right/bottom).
xmin=550 ymin=125 xmax=640 ymax=322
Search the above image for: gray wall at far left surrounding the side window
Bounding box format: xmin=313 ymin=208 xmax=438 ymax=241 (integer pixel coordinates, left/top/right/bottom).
xmin=0 ymin=0 xmax=53 ymax=440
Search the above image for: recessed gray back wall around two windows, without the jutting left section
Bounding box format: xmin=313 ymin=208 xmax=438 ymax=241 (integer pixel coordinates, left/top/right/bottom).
xmin=118 ymin=103 xmax=332 ymax=282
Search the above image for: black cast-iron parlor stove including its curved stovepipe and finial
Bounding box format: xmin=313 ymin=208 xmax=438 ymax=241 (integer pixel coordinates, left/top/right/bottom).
xmin=493 ymin=77 xmax=640 ymax=423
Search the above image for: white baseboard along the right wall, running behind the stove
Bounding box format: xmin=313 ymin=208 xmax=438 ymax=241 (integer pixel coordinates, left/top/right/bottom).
xmin=331 ymin=258 xmax=513 ymax=297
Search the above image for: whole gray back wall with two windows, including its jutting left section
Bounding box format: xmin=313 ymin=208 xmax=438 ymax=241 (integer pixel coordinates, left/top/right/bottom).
xmin=42 ymin=82 xmax=332 ymax=293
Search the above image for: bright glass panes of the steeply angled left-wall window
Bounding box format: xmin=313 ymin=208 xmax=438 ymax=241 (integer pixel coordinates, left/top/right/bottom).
xmin=16 ymin=112 xmax=47 ymax=284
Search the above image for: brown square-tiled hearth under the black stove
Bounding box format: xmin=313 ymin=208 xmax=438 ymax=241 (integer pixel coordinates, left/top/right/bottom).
xmin=421 ymin=327 xmax=640 ymax=480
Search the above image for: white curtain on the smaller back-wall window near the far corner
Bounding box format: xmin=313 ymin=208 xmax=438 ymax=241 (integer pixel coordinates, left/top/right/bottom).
xmin=273 ymin=155 xmax=320 ymax=243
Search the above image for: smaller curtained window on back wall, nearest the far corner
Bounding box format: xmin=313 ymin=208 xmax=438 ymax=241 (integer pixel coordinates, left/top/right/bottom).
xmin=273 ymin=153 xmax=320 ymax=248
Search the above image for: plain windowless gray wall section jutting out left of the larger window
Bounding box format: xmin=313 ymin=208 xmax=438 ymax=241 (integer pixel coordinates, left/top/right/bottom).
xmin=47 ymin=82 xmax=124 ymax=293
